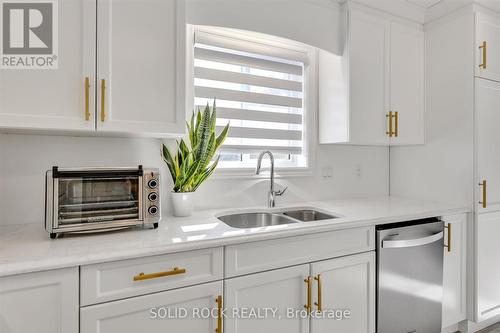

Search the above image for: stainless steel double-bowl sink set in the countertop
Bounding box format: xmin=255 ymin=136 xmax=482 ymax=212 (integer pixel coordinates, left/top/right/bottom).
xmin=218 ymin=209 xmax=338 ymax=229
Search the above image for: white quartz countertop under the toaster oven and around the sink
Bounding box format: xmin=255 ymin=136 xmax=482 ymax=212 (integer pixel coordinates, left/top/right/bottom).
xmin=0 ymin=197 xmax=468 ymax=276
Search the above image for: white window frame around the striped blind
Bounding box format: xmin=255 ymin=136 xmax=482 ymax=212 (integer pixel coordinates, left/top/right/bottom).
xmin=186 ymin=24 xmax=318 ymax=179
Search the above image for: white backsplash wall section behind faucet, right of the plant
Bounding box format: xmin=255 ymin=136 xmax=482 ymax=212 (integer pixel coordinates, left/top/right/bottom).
xmin=198 ymin=145 xmax=389 ymax=208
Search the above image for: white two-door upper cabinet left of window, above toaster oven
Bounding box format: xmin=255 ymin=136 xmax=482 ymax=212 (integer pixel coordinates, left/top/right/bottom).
xmin=0 ymin=0 xmax=186 ymax=137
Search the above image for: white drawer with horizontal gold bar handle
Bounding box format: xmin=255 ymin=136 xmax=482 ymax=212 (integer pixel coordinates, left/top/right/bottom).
xmin=80 ymin=248 xmax=223 ymax=306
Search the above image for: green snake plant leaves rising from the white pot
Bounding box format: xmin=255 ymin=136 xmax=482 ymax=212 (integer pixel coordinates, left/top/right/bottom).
xmin=162 ymin=101 xmax=229 ymax=192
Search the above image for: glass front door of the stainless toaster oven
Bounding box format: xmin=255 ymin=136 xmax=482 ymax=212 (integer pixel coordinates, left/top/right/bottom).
xmin=54 ymin=170 xmax=143 ymax=229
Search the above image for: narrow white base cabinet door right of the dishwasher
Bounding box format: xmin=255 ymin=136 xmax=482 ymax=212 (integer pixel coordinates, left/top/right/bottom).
xmin=442 ymin=214 xmax=467 ymax=328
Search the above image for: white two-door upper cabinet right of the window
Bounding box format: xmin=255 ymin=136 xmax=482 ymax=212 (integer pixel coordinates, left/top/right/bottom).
xmin=319 ymin=9 xmax=425 ymax=145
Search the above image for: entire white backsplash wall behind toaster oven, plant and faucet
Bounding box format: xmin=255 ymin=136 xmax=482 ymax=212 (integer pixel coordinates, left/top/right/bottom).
xmin=0 ymin=134 xmax=389 ymax=225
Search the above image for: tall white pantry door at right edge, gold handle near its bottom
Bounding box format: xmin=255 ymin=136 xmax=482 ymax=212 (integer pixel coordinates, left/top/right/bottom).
xmin=474 ymin=79 xmax=500 ymax=212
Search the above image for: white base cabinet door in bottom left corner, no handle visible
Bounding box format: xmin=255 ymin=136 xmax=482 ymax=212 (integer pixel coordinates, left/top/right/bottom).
xmin=0 ymin=268 xmax=79 ymax=333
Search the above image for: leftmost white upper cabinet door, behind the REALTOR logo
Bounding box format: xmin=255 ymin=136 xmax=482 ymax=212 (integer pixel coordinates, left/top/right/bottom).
xmin=0 ymin=0 xmax=96 ymax=131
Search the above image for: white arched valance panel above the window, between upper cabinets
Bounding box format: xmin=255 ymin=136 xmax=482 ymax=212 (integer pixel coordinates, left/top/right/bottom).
xmin=186 ymin=0 xmax=345 ymax=54
